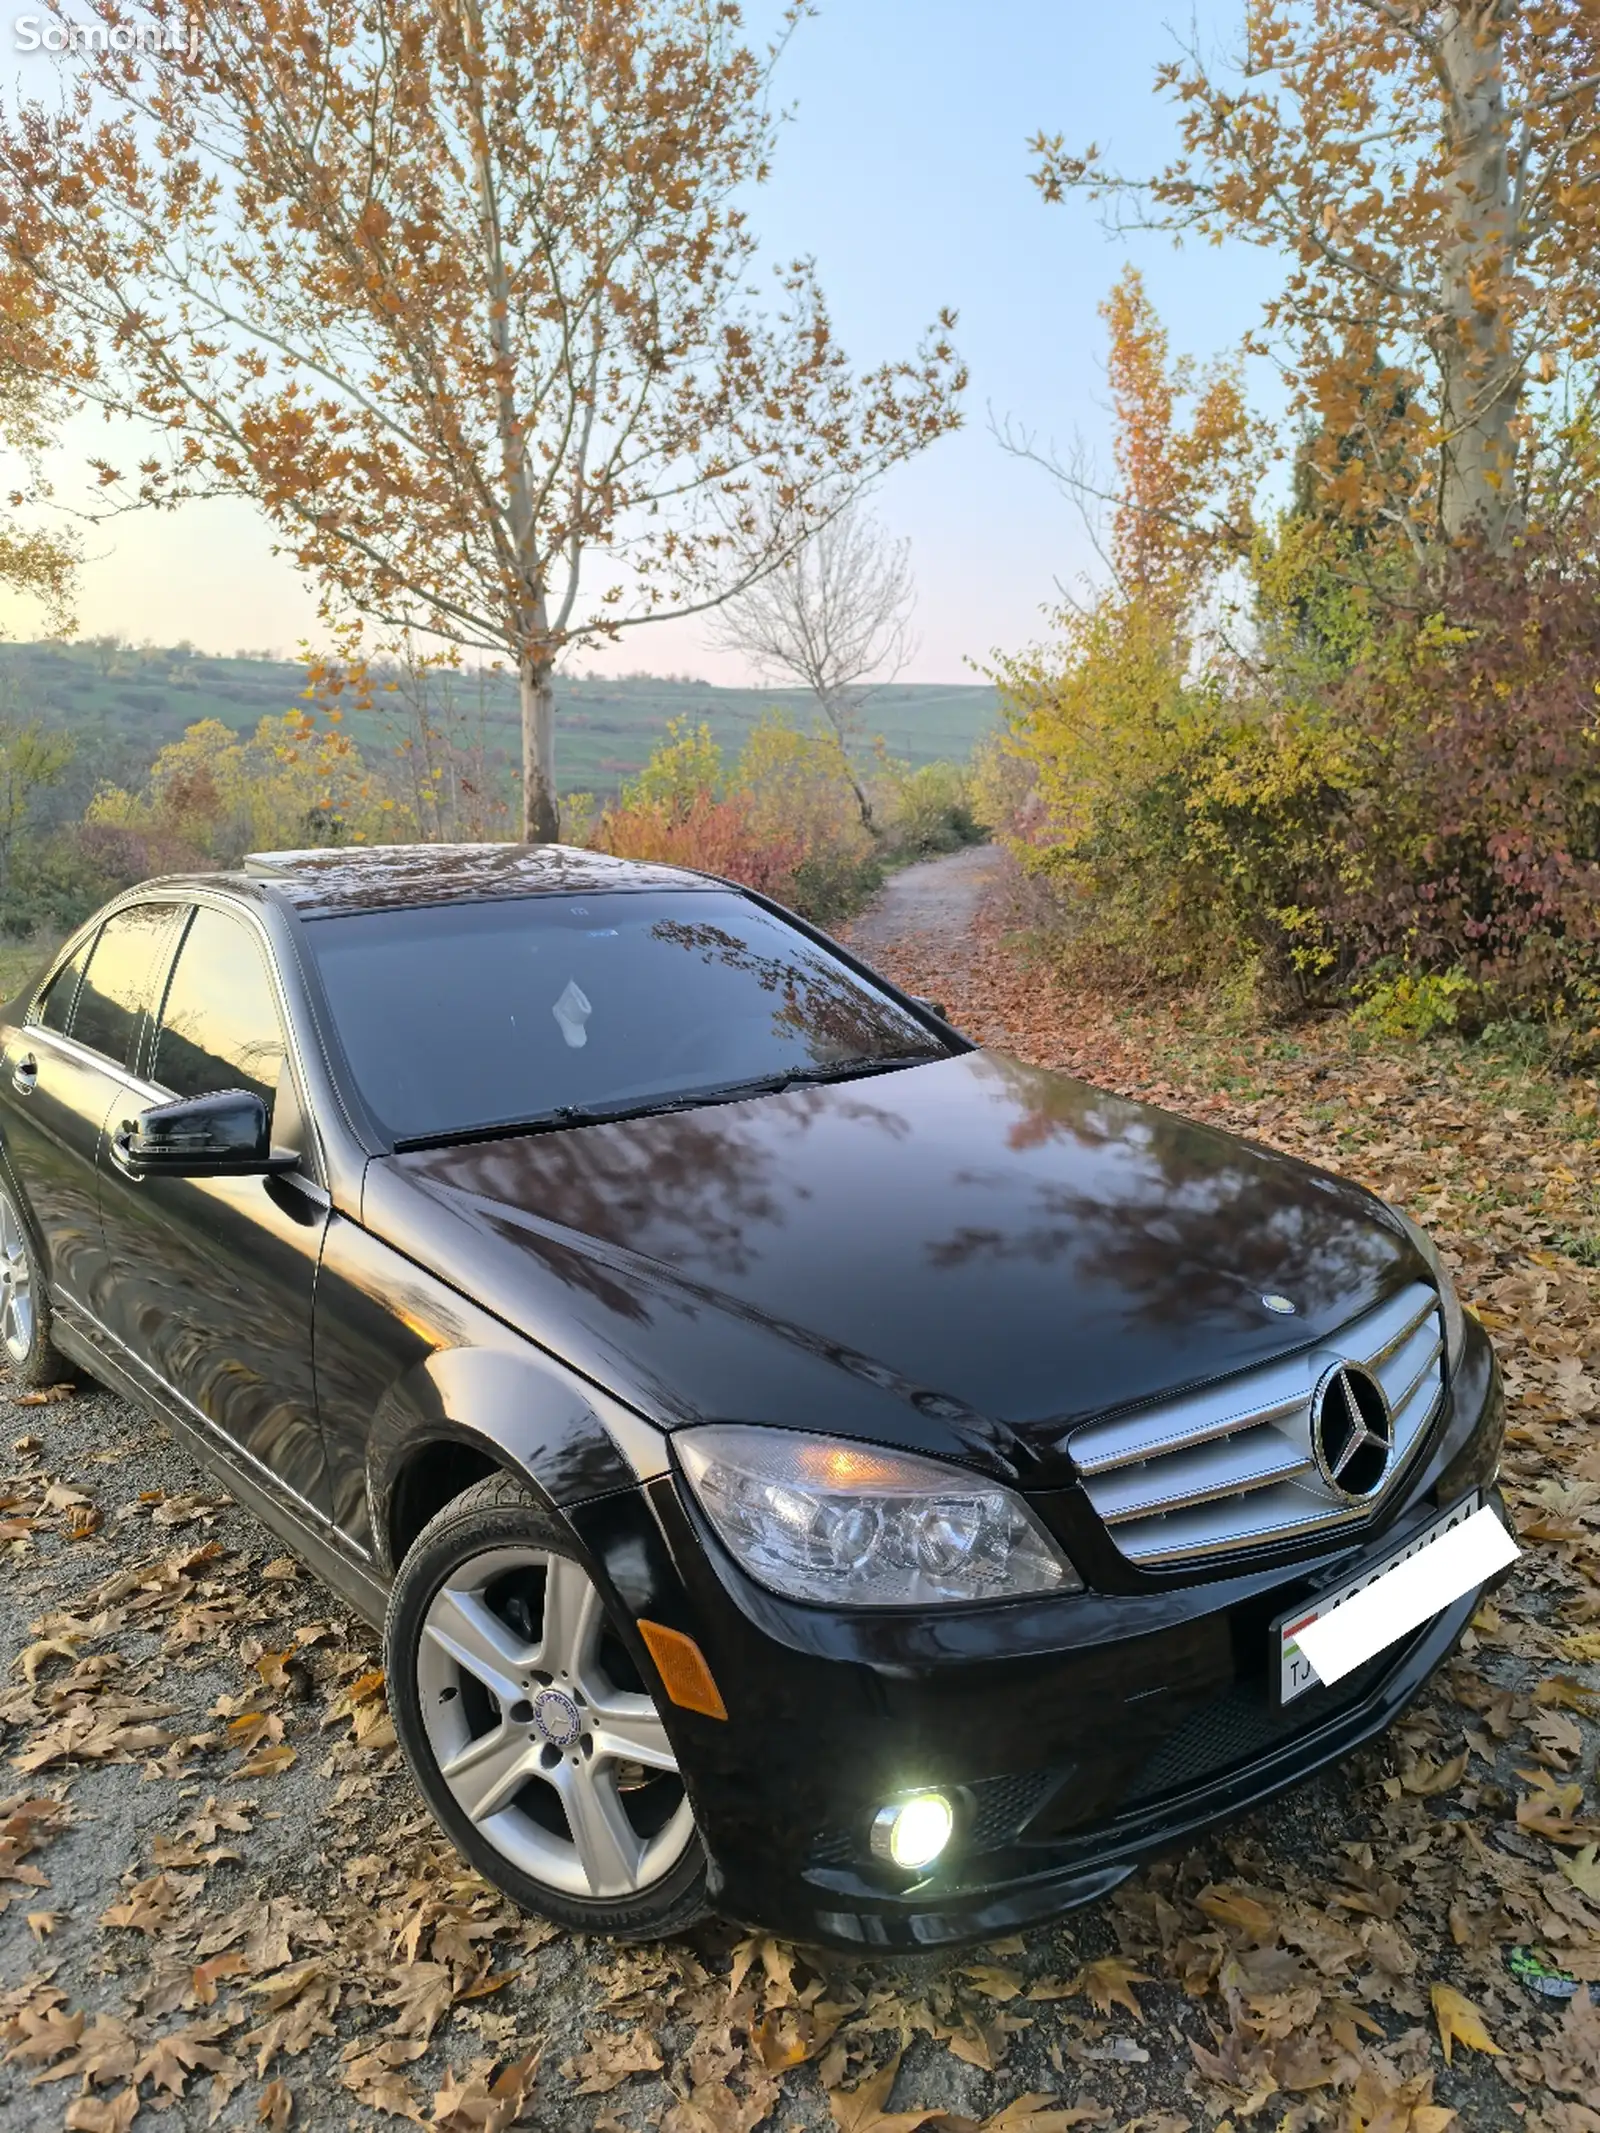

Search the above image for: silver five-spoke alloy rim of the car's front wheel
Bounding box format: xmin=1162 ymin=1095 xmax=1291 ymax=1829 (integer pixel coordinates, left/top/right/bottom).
xmin=416 ymin=1546 xmax=693 ymax=1898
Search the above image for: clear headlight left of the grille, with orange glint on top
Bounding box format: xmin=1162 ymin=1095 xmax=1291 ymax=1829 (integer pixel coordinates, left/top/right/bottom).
xmin=672 ymin=1427 xmax=1084 ymax=1606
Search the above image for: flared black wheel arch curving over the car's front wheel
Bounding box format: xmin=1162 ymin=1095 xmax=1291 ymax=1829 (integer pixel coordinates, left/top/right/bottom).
xmin=367 ymin=1344 xmax=668 ymax=1576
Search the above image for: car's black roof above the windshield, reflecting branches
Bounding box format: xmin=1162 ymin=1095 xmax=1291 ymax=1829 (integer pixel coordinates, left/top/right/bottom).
xmin=231 ymin=845 xmax=721 ymax=919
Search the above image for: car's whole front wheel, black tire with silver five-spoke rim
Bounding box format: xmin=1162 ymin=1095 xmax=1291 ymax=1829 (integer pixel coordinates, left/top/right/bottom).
xmin=384 ymin=1474 xmax=708 ymax=1941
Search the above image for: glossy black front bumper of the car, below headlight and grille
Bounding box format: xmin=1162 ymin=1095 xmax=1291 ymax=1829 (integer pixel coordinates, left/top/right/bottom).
xmin=585 ymin=1322 xmax=1504 ymax=1952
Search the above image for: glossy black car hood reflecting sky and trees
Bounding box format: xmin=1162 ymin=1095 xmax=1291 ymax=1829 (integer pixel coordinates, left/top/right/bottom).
xmin=363 ymin=1052 xmax=1421 ymax=1480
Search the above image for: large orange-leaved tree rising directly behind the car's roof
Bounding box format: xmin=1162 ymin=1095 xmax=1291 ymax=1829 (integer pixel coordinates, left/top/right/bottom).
xmin=0 ymin=0 xmax=962 ymax=838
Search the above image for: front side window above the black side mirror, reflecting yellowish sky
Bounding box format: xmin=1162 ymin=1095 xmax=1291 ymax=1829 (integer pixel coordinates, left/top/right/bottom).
xmin=151 ymin=904 xmax=284 ymax=1103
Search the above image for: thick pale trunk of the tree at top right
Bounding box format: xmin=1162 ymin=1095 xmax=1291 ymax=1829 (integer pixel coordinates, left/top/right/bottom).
xmin=1436 ymin=0 xmax=1523 ymax=550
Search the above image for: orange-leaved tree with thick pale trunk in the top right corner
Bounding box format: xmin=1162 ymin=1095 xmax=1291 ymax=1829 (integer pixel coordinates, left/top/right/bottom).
xmin=1033 ymin=0 xmax=1600 ymax=555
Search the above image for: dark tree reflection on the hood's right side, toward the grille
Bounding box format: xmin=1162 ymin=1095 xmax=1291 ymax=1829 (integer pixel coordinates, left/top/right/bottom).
xmin=928 ymin=1060 xmax=1393 ymax=1318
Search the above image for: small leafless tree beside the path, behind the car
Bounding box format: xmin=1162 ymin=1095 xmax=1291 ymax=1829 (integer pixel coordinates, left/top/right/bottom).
xmin=717 ymin=508 xmax=917 ymax=830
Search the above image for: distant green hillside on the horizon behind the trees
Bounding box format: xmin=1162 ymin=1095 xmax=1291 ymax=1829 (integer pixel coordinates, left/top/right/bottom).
xmin=0 ymin=644 xmax=996 ymax=793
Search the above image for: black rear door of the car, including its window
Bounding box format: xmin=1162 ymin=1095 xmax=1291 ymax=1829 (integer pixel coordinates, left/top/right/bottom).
xmin=0 ymin=904 xmax=177 ymax=1316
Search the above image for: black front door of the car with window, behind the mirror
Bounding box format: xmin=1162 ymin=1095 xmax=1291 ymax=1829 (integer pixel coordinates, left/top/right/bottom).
xmin=100 ymin=904 xmax=329 ymax=1514
